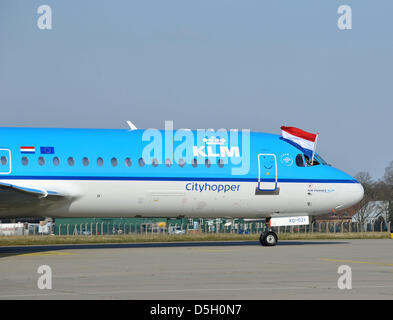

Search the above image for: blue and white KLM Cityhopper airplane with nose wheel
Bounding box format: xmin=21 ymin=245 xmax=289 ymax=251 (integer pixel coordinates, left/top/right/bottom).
xmin=0 ymin=127 xmax=364 ymax=246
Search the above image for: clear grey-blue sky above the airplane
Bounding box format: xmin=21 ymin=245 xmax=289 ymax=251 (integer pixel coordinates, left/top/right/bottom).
xmin=0 ymin=0 xmax=393 ymax=179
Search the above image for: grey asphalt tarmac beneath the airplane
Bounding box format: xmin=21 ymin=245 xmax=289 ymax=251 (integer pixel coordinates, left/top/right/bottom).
xmin=0 ymin=239 xmax=393 ymax=300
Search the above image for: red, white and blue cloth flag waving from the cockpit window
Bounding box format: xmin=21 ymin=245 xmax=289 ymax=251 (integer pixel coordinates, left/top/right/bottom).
xmin=281 ymin=126 xmax=318 ymax=158
